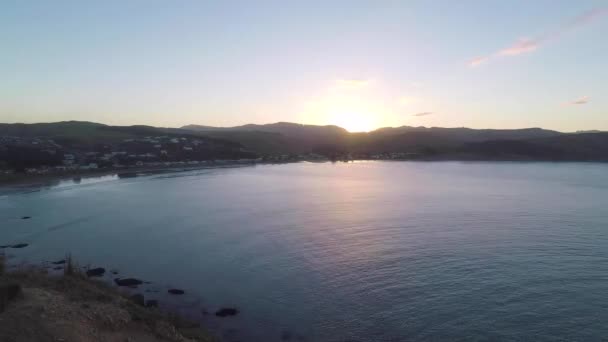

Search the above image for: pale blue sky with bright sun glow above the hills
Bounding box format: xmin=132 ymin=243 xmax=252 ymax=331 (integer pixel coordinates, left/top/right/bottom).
xmin=0 ymin=0 xmax=608 ymax=131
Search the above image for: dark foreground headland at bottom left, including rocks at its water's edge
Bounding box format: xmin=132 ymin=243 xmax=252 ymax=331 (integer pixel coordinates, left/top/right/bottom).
xmin=0 ymin=251 xmax=239 ymax=342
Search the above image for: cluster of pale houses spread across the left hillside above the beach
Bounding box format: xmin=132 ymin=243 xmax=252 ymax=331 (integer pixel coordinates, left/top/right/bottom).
xmin=0 ymin=136 xmax=255 ymax=174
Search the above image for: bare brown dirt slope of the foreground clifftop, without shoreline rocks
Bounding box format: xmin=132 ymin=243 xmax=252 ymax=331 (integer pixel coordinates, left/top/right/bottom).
xmin=0 ymin=270 xmax=216 ymax=342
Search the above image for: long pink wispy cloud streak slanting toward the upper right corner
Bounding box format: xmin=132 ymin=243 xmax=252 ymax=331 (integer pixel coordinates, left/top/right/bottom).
xmin=468 ymin=7 xmax=608 ymax=67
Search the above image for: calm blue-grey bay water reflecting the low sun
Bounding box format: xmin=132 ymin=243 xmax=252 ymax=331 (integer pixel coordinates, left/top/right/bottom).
xmin=0 ymin=162 xmax=608 ymax=341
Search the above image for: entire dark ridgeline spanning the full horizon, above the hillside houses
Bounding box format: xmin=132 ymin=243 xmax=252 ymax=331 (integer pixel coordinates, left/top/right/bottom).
xmin=0 ymin=121 xmax=608 ymax=161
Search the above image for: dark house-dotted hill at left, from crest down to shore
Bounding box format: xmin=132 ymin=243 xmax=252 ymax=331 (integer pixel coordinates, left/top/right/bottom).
xmin=0 ymin=121 xmax=257 ymax=171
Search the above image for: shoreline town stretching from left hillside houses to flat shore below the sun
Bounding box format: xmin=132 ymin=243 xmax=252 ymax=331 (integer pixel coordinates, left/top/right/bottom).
xmin=0 ymin=135 xmax=428 ymax=175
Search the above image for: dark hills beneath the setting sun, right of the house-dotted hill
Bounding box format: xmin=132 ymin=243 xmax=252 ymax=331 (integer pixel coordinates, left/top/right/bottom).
xmin=182 ymin=122 xmax=608 ymax=161
